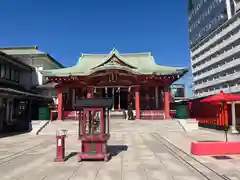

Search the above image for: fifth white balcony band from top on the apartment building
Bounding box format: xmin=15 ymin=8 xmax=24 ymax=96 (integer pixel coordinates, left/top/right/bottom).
xmin=194 ymin=72 xmax=240 ymax=90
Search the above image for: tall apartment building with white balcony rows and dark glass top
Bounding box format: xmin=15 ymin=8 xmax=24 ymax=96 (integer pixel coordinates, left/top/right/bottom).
xmin=188 ymin=0 xmax=240 ymax=97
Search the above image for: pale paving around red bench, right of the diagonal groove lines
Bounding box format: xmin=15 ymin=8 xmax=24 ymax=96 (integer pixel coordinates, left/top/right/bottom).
xmin=163 ymin=129 xmax=240 ymax=180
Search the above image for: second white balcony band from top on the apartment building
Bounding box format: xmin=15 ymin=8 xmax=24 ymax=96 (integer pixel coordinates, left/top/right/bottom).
xmin=192 ymin=32 xmax=240 ymax=65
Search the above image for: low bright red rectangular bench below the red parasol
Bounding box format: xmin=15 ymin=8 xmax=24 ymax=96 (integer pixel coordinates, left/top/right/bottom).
xmin=191 ymin=142 xmax=240 ymax=155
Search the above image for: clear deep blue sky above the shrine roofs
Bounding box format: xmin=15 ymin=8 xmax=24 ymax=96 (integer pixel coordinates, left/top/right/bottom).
xmin=0 ymin=0 xmax=190 ymax=95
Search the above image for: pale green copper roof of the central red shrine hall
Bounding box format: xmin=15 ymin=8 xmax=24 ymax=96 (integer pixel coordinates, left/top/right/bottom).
xmin=42 ymin=49 xmax=188 ymax=76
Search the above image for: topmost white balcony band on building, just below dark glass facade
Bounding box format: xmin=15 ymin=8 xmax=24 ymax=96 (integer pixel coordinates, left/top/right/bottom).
xmin=191 ymin=18 xmax=240 ymax=57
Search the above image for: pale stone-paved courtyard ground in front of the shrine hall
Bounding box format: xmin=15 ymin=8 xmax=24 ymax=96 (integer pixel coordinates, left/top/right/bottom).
xmin=0 ymin=120 xmax=240 ymax=180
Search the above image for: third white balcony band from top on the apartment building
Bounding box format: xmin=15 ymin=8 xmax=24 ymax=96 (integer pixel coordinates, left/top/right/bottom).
xmin=192 ymin=45 xmax=240 ymax=73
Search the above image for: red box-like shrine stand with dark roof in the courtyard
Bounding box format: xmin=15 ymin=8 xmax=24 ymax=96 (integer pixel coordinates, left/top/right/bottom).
xmin=75 ymin=98 xmax=113 ymax=161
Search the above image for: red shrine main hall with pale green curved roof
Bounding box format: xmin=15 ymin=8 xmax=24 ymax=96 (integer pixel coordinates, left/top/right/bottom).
xmin=42 ymin=49 xmax=188 ymax=120
